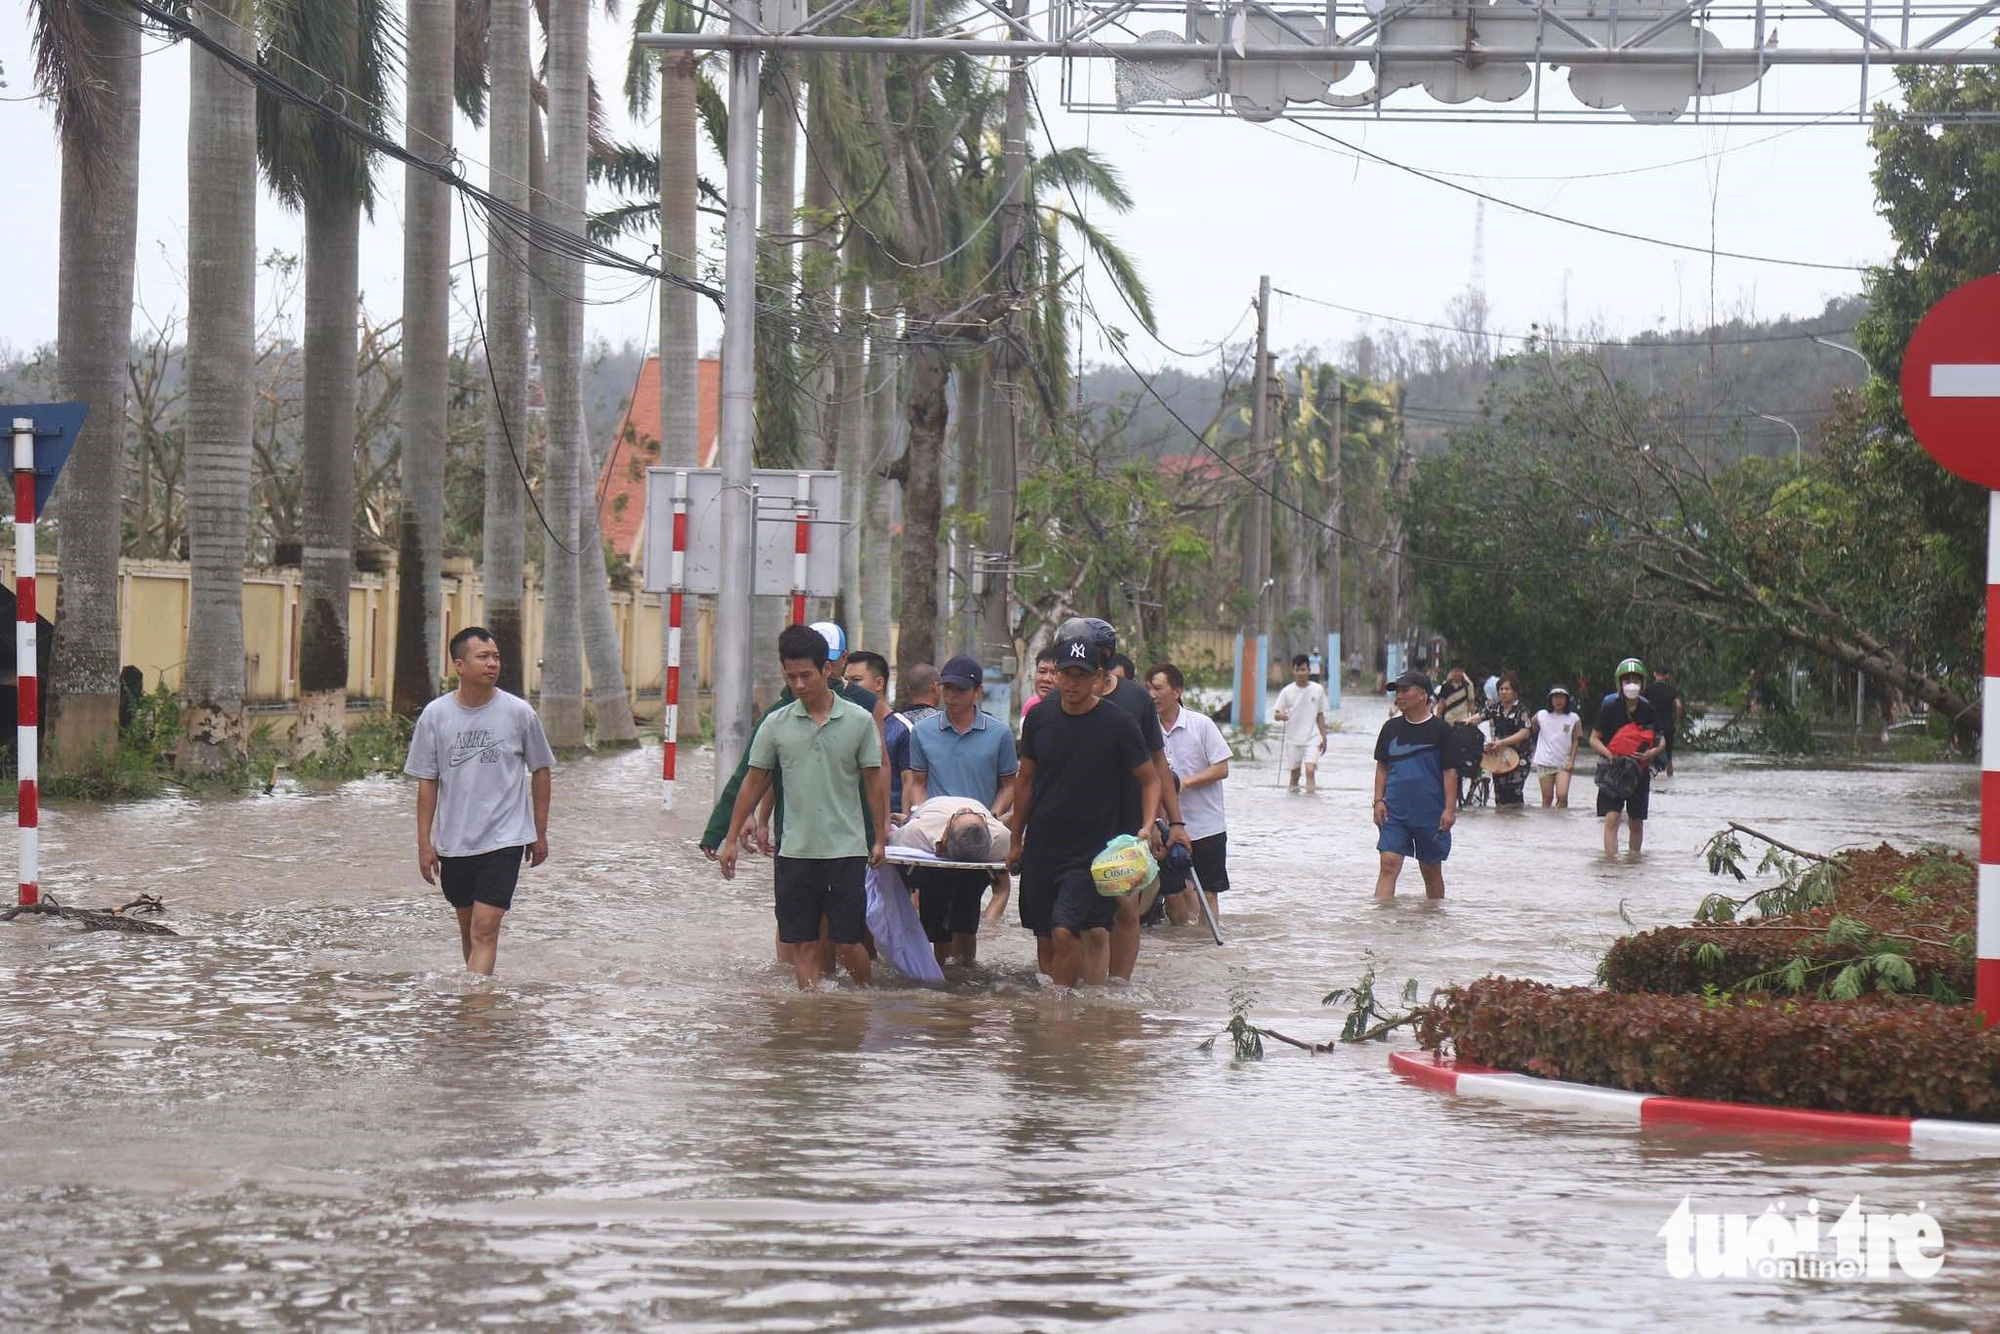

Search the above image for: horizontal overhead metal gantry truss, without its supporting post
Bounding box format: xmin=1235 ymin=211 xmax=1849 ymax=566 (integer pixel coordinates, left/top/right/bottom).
xmin=638 ymin=0 xmax=2000 ymax=122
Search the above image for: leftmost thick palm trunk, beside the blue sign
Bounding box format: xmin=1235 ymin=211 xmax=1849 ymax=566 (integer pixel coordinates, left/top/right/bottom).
xmin=46 ymin=4 xmax=140 ymax=772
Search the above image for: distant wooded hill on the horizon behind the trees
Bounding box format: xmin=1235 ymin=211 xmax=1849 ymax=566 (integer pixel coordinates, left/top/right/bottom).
xmin=1082 ymin=296 xmax=1868 ymax=468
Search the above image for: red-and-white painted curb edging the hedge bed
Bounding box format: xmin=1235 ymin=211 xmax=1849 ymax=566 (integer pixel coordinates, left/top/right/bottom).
xmin=1388 ymin=1052 xmax=2000 ymax=1156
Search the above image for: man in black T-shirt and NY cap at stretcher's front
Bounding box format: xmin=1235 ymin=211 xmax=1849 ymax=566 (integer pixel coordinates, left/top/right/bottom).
xmin=1008 ymin=638 xmax=1160 ymax=986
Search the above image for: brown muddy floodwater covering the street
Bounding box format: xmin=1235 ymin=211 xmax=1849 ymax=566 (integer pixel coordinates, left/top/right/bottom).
xmin=0 ymin=700 xmax=2000 ymax=1332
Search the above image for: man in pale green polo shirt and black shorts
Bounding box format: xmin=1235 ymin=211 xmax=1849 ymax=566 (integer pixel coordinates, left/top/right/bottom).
xmin=718 ymin=626 xmax=888 ymax=992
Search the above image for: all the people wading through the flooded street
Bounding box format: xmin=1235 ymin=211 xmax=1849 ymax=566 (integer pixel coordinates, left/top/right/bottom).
xmin=404 ymin=616 xmax=1684 ymax=990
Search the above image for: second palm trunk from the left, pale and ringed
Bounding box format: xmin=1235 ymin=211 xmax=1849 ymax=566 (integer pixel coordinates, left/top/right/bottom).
xmin=180 ymin=0 xmax=256 ymax=772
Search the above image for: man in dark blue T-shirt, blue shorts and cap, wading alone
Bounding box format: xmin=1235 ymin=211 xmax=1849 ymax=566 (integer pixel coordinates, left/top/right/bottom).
xmin=1374 ymin=672 xmax=1458 ymax=898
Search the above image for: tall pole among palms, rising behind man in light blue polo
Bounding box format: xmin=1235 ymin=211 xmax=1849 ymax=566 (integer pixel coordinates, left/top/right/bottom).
xmin=968 ymin=0 xmax=1028 ymax=676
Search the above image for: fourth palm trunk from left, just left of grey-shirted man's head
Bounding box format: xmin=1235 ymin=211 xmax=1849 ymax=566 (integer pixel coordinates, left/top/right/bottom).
xmin=392 ymin=0 xmax=456 ymax=718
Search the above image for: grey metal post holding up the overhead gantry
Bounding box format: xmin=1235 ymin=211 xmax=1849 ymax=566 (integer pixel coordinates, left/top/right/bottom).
xmin=714 ymin=6 xmax=760 ymax=792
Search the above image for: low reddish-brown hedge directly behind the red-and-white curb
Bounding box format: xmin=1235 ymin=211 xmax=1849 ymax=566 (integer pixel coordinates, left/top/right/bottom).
xmin=1418 ymin=978 xmax=2000 ymax=1120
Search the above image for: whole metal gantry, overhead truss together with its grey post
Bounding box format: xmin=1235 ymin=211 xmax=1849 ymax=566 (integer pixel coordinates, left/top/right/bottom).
xmin=636 ymin=0 xmax=2000 ymax=788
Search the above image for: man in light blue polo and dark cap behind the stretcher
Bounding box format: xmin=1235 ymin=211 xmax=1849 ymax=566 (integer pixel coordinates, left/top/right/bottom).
xmin=902 ymin=654 xmax=1020 ymax=966
